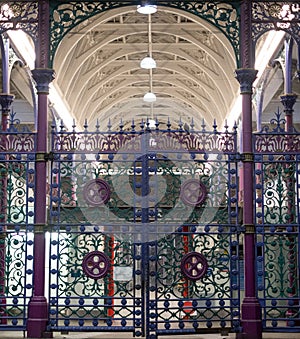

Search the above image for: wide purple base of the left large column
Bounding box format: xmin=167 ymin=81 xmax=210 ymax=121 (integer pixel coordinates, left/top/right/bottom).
xmin=26 ymin=296 xmax=53 ymax=338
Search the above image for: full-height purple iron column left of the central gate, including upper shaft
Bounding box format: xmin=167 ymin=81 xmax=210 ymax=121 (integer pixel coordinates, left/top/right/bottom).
xmin=27 ymin=0 xmax=54 ymax=338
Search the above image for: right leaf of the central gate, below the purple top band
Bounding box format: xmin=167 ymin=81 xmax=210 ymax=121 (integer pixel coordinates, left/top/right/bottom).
xmin=146 ymin=145 xmax=240 ymax=338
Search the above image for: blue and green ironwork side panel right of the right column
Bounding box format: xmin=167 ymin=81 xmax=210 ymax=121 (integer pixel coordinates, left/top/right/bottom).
xmin=254 ymin=113 xmax=300 ymax=332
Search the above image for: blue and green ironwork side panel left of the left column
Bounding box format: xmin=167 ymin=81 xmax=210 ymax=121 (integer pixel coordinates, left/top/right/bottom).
xmin=0 ymin=120 xmax=35 ymax=330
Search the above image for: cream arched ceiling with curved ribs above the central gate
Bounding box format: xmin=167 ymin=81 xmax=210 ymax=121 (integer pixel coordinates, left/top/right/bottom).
xmin=54 ymin=7 xmax=239 ymax=130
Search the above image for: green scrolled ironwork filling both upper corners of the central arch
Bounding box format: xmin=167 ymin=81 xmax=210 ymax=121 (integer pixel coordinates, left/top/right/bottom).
xmin=50 ymin=0 xmax=240 ymax=67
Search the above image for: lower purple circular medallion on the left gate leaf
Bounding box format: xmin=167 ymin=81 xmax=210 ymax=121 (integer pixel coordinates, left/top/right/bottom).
xmin=82 ymin=251 xmax=110 ymax=279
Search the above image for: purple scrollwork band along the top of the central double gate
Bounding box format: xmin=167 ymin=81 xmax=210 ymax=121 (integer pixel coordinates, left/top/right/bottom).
xmin=52 ymin=119 xmax=236 ymax=154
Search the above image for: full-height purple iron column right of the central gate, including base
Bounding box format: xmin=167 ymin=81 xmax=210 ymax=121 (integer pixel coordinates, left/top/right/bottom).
xmin=236 ymin=0 xmax=262 ymax=339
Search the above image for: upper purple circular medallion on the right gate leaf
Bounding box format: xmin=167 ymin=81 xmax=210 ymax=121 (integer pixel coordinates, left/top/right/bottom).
xmin=180 ymin=179 xmax=207 ymax=206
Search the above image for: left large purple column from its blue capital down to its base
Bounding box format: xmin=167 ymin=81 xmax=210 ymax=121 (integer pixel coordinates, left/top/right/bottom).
xmin=27 ymin=69 xmax=54 ymax=338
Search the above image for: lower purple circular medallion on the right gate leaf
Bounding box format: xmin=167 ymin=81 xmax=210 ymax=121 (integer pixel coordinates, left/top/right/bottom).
xmin=180 ymin=252 xmax=208 ymax=281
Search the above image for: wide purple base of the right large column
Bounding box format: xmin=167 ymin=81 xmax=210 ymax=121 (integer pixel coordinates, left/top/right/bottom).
xmin=237 ymin=298 xmax=262 ymax=339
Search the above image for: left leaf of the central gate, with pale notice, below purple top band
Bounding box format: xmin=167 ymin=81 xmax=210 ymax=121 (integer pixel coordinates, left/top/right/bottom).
xmin=49 ymin=145 xmax=144 ymax=336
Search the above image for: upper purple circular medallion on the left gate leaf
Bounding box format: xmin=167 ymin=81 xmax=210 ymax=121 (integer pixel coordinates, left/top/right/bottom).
xmin=83 ymin=178 xmax=110 ymax=206
